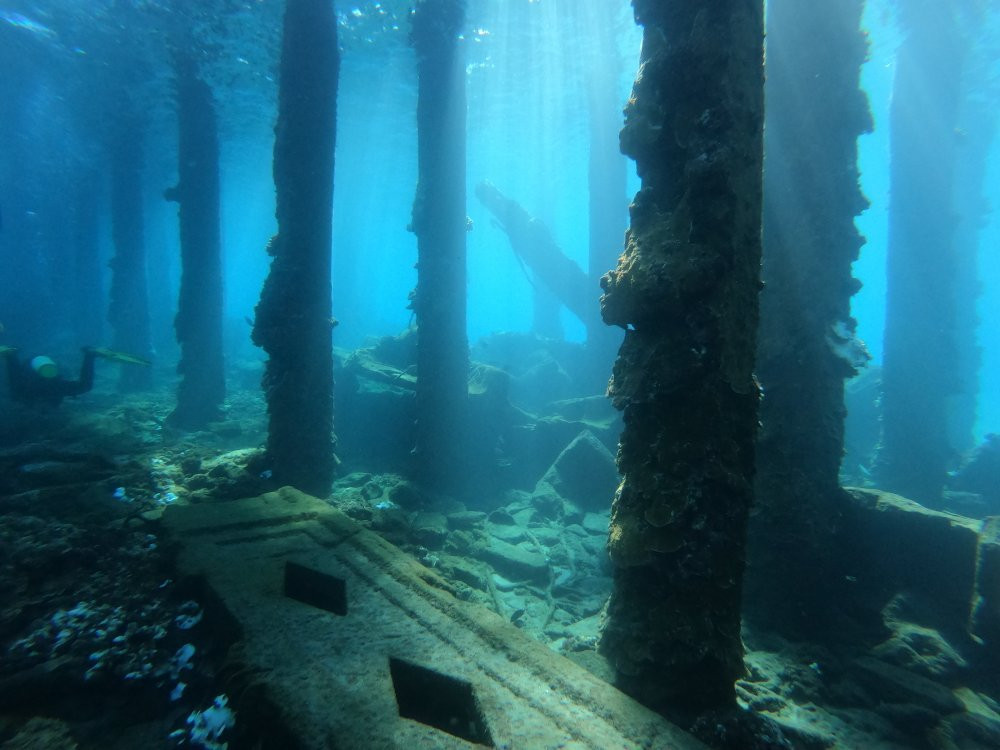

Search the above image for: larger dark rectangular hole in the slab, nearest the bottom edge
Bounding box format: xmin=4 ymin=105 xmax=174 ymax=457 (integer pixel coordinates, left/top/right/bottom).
xmin=389 ymin=656 xmax=493 ymax=747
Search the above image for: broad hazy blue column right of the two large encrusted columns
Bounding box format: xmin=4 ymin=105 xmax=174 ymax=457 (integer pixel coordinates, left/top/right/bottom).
xmin=877 ymin=0 xmax=964 ymax=504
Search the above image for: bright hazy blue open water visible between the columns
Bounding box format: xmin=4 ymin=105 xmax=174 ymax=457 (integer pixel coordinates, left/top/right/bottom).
xmin=0 ymin=0 xmax=1000 ymax=437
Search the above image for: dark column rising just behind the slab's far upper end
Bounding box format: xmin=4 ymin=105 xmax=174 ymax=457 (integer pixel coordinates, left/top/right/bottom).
xmin=253 ymin=0 xmax=340 ymax=497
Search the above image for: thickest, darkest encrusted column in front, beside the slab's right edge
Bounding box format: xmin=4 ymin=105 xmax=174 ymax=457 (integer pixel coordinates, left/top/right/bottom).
xmin=601 ymin=0 xmax=764 ymax=723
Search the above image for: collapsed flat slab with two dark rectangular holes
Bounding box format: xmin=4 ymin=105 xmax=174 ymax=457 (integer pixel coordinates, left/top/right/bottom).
xmin=163 ymin=488 xmax=704 ymax=750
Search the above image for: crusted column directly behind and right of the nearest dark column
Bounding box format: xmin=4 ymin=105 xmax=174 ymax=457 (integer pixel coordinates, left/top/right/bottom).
xmin=746 ymin=0 xmax=872 ymax=633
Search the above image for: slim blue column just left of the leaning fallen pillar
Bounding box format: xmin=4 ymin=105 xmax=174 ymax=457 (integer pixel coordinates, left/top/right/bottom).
xmin=410 ymin=0 xmax=469 ymax=490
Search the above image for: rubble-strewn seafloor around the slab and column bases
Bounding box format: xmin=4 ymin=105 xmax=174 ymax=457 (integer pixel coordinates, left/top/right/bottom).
xmin=0 ymin=338 xmax=1000 ymax=749
